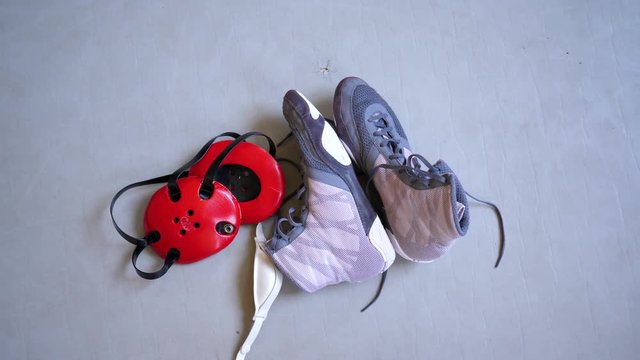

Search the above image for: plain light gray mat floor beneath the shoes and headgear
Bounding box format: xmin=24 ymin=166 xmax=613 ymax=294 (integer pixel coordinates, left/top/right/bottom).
xmin=0 ymin=0 xmax=640 ymax=360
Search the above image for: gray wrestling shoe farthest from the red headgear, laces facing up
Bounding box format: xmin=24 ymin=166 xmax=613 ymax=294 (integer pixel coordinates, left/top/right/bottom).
xmin=333 ymin=77 xmax=469 ymax=262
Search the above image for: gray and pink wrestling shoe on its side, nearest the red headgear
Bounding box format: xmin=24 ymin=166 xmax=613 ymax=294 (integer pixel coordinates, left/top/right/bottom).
xmin=263 ymin=90 xmax=395 ymax=292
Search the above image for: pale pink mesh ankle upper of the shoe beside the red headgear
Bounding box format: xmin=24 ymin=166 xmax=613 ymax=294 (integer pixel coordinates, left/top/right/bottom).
xmin=272 ymin=178 xmax=385 ymax=292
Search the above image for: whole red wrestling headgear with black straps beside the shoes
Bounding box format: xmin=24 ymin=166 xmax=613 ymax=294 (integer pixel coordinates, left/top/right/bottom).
xmin=110 ymin=132 xmax=284 ymax=279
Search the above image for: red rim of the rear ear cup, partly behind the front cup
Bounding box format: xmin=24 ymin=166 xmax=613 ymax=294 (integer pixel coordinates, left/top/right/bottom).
xmin=189 ymin=140 xmax=285 ymax=224
